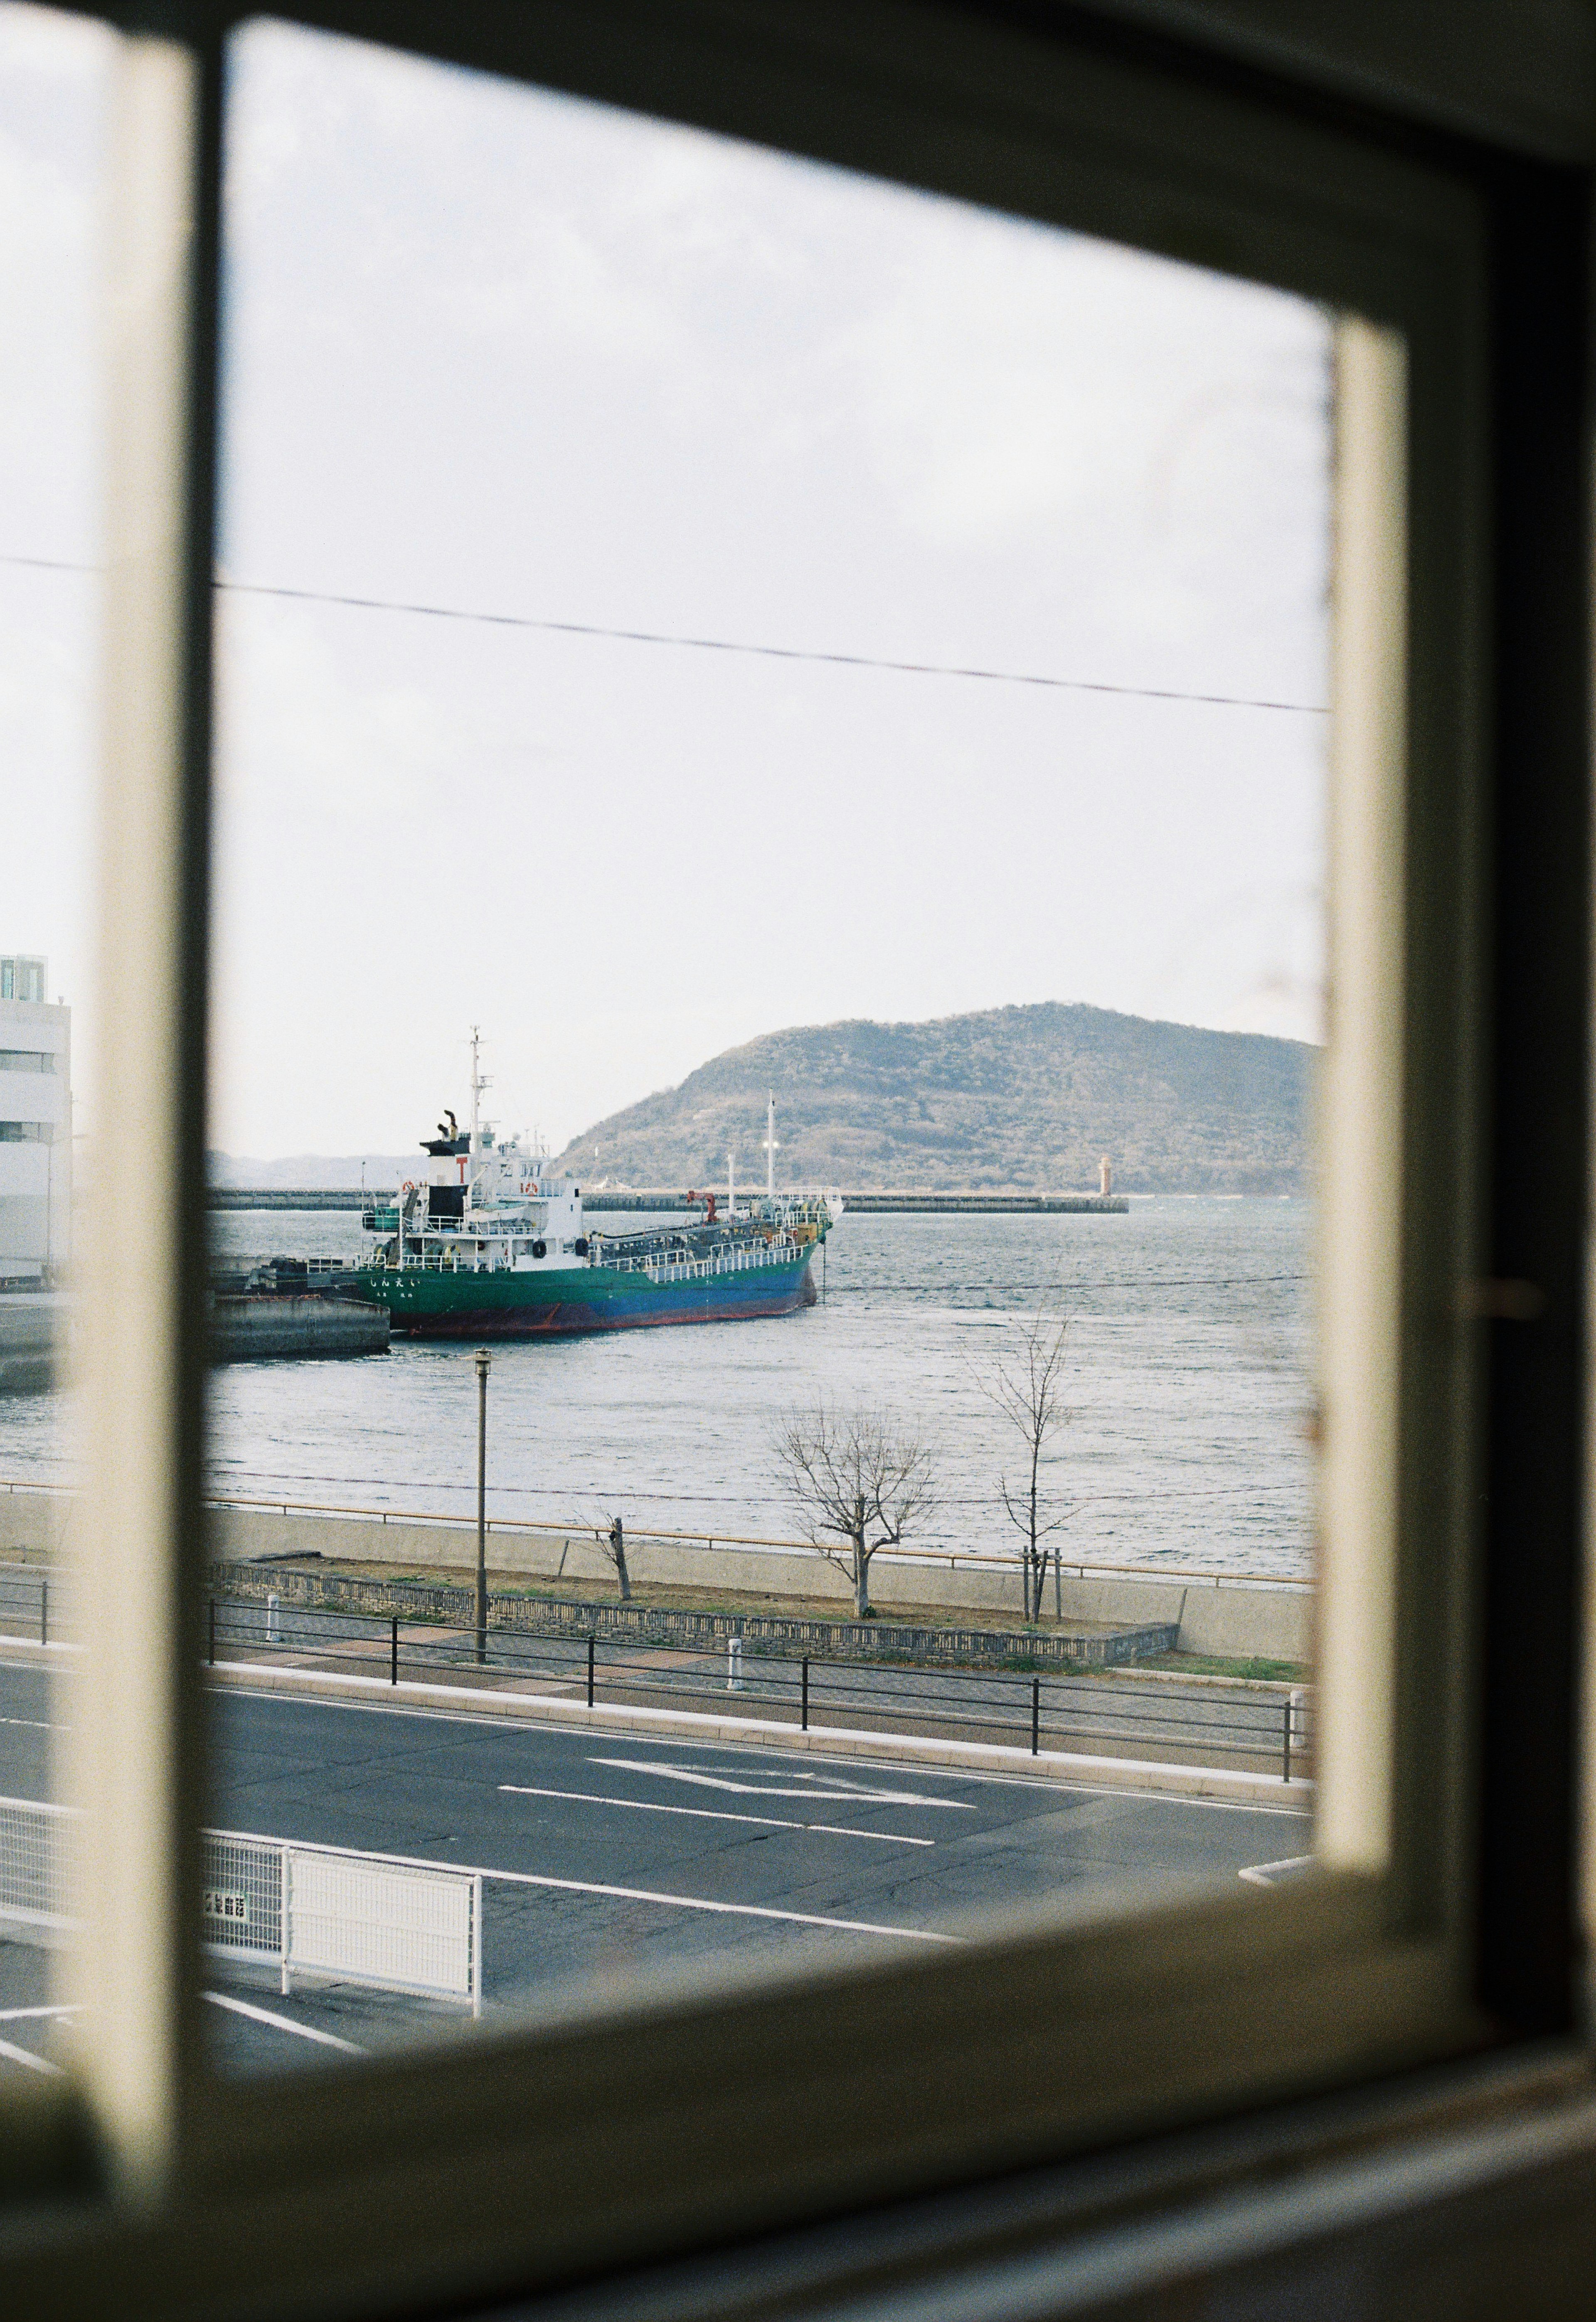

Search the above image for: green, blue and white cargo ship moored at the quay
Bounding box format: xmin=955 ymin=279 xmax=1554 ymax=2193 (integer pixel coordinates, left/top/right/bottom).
xmin=355 ymin=1040 xmax=841 ymax=1340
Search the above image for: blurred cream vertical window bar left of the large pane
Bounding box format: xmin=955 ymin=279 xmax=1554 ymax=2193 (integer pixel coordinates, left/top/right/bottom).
xmin=65 ymin=18 xmax=221 ymax=2194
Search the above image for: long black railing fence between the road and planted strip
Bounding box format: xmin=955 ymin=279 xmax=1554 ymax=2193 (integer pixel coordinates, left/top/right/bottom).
xmin=207 ymin=1595 xmax=1310 ymax=1783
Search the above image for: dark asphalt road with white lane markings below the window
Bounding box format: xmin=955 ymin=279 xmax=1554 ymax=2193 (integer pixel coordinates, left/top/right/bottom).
xmin=0 ymin=1665 xmax=1310 ymax=2071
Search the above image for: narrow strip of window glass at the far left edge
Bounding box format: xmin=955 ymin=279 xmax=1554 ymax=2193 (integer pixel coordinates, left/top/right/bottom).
xmin=0 ymin=7 xmax=111 ymax=2099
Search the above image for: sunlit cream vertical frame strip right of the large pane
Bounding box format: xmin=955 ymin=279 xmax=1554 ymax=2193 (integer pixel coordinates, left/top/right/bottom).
xmin=1317 ymin=318 xmax=1408 ymax=1869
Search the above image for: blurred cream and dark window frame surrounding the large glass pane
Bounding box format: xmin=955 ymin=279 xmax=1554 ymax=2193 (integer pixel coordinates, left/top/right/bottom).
xmin=0 ymin=0 xmax=1589 ymax=2310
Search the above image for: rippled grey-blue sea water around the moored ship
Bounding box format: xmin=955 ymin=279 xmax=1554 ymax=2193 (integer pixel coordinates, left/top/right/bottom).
xmin=0 ymin=1198 xmax=1315 ymax=1579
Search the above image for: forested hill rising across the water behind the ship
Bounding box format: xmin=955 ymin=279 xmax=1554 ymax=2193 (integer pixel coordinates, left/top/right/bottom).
xmin=560 ymin=1003 xmax=1317 ymax=1194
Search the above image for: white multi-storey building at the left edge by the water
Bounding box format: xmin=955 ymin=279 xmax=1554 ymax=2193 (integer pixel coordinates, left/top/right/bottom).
xmin=0 ymin=952 xmax=72 ymax=1282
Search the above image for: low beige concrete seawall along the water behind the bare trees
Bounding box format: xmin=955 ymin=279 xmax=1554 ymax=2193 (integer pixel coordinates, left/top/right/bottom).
xmin=0 ymin=1491 xmax=1313 ymax=1662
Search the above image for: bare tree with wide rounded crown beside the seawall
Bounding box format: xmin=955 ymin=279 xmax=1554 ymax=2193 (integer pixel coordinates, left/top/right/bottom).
xmin=776 ymin=1398 xmax=936 ymax=1618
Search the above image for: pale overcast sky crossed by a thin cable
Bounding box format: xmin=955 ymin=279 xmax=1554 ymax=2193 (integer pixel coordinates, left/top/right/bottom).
xmin=0 ymin=7 xmax=1329 ymax=1154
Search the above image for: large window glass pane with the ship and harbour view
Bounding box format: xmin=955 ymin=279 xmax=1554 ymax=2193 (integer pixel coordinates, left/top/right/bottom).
xmin=204 ymin=25 xmax=1333 ymax=2071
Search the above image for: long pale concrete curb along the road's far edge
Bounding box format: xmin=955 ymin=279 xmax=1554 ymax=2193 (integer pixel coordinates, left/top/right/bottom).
xmin=204 ymin=1660 xmax=1315 ymax=1809
